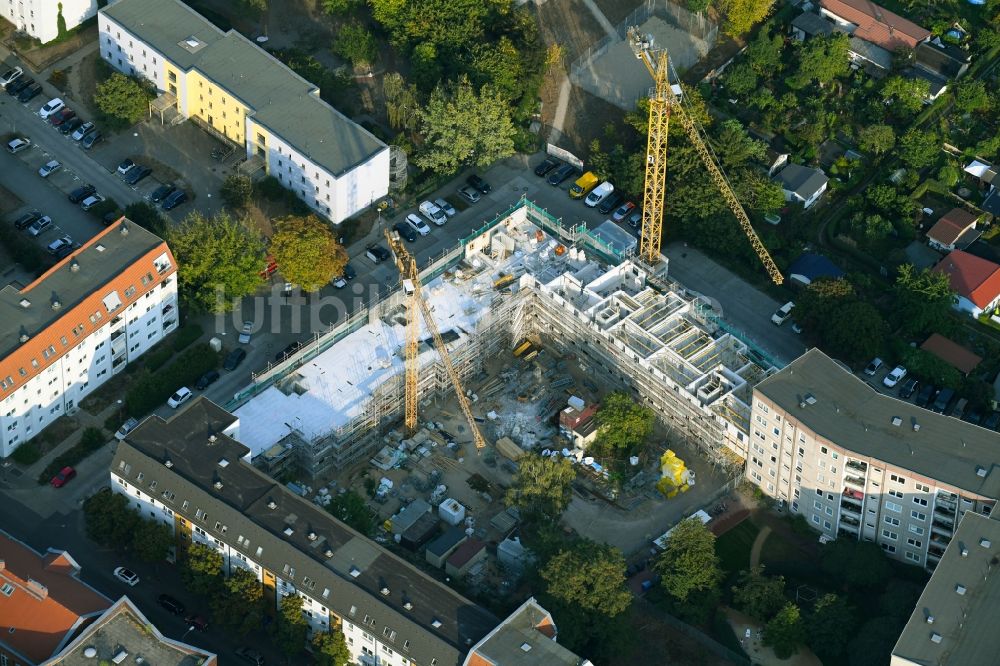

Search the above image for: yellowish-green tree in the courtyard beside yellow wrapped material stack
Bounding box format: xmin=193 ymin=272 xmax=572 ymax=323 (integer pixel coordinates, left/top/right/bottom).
xmin=507 ymin=453 xmax=576 ymax=521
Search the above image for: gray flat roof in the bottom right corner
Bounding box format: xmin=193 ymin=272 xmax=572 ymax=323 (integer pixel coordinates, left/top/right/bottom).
xmin=892 ymin=511 xmax=1000 ymax=666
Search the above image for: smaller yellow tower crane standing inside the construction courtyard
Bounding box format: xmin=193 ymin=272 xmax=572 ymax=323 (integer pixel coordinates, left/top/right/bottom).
xmin=385 ymin=229 xmax=486 ymax=451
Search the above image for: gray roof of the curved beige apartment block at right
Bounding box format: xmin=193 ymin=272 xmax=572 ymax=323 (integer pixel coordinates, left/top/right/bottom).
xmin=755 ymin=349 xmax=1000 ymax=499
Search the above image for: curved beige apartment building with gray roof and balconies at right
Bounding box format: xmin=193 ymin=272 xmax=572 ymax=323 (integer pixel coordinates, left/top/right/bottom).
xmin=746 ymin=349 xmax=1000 ymax=569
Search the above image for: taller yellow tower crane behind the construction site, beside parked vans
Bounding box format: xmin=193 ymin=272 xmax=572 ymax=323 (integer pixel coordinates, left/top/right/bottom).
xmin=628 ymin=26 xmax=784 ymax=284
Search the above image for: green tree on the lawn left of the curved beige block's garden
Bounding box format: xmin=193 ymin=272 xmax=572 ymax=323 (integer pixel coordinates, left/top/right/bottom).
xmin=653 ymin=518 xmax=722 ymax=602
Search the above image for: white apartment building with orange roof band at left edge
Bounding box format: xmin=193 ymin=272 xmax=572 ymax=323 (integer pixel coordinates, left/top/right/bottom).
xmin=0 ymin=218 xmax=178 ymax=458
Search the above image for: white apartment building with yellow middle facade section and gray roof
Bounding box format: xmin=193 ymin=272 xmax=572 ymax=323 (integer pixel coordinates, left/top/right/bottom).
xmin=96 ymin=0 xmax=389 ymax=224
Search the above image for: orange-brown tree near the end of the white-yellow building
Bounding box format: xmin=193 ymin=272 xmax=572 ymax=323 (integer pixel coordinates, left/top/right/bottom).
xmin=268 ymin=215 xmax=347 ymax=292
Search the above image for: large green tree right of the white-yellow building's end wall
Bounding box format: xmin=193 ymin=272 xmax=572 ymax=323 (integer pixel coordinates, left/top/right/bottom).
xmin=414 ymin=76 xmax=515 ymax=174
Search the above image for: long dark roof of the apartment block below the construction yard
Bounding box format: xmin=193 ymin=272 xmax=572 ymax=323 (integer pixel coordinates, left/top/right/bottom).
xmin=111 ymin=397 xmax=497 ymax=666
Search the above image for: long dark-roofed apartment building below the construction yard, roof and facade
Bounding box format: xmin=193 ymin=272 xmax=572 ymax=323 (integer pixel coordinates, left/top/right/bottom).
xmin=110 ymin=398 xmax=498 ymax=666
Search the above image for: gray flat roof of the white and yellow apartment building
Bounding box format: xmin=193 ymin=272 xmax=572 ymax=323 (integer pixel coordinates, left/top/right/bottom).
xmin=101 ymin=0 xmax=387 ymax=176
